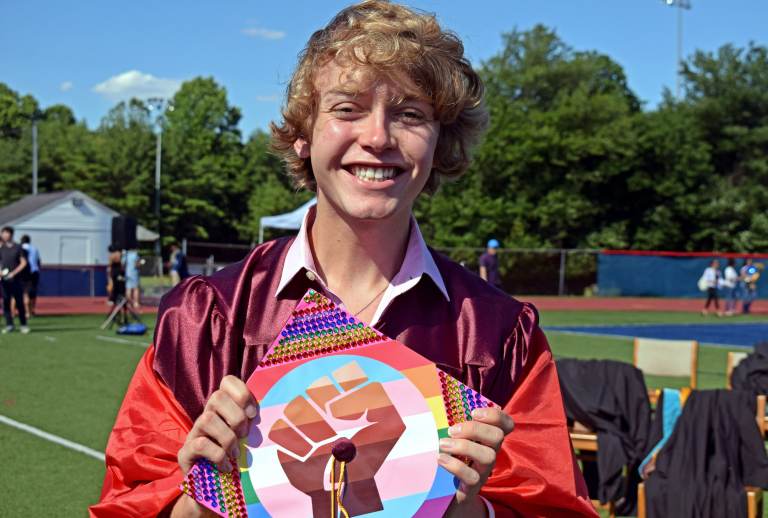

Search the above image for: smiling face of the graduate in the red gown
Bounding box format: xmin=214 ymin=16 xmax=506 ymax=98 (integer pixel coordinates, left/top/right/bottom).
xmin=294 ymin=62 xmax=440 ymax=224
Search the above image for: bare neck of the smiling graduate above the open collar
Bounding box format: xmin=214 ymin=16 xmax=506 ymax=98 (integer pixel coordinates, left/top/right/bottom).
xmin=309 ymin=197 xmax=410 ymax=311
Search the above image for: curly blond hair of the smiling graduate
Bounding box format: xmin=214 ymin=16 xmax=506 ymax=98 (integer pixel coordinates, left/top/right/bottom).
xmin=270 ymin=0 xmax=488 ymax=193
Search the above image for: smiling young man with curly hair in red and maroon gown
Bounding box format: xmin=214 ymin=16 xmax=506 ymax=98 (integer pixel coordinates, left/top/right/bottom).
xmin=91 ymin=1 xmax=596 ymax=517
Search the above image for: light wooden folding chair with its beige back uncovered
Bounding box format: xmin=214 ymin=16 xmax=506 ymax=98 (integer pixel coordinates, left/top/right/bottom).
xmin=633 ymin=338 xmax=699 ymax=404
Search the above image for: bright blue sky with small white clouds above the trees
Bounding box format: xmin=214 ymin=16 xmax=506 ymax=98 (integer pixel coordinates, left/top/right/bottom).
xmin=0 ymin=0 xmax=768 ymax=139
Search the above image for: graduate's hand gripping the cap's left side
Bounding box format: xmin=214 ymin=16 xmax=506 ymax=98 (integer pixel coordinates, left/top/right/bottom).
xmin=178 ymin=376 xmax=259 ymax=476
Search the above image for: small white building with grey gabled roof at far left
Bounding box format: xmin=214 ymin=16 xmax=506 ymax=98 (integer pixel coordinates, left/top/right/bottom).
xmin=0 ymin=191 xmax=157 ymax=266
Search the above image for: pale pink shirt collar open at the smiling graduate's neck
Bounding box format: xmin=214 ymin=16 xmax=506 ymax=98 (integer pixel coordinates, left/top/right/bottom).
xmin=275 ymin=207 xmax=450 ymax=325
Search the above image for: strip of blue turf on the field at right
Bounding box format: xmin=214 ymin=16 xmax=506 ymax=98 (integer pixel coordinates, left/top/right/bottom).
xmin=544 ymin=322 xmax=768 ymax=348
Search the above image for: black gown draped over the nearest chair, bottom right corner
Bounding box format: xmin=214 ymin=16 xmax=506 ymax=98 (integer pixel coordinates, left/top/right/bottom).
xmin=645 ymin=390 xmax=768 ymax=518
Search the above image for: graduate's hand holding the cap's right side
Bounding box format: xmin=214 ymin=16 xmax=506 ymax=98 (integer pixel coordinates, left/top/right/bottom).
xmin=438 ymin=408 xmax=514 ymax=516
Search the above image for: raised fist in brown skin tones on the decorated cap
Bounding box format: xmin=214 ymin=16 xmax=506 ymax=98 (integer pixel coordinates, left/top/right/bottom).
xmin=269 ymin=361 xmax=405 ymax=518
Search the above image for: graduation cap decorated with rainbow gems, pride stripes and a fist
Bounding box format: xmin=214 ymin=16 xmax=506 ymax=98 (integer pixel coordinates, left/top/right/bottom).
xmin=182 ymin=290 xmax=495 ymax=518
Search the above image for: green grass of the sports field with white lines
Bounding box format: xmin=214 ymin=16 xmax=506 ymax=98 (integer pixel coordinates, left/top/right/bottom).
xmin=0 ymin=311 xmax=758 ymax=516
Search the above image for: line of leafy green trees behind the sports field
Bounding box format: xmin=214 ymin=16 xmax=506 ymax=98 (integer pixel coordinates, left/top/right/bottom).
xmin=0 ymin=26 xmax=768 ymax=252
